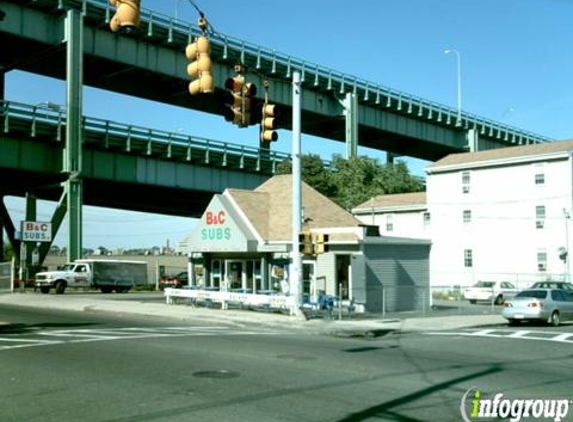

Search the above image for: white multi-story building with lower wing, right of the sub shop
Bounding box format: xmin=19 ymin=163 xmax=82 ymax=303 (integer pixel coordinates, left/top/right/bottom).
xmin=355 ymin=141 xmax=573 ymax=287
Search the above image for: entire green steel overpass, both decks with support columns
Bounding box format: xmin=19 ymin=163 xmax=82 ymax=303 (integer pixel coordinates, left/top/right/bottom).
xmin=0 ymin=0 xmax=551 ymax=260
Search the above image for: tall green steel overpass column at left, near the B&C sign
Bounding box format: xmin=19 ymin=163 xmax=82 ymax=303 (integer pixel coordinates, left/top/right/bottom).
xmin=63 ymin=9 xmax=83 ymax=262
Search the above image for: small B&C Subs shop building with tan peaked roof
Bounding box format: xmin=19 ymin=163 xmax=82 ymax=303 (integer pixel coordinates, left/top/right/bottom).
xmin=170 ymin=175 xmax=430 ymax=312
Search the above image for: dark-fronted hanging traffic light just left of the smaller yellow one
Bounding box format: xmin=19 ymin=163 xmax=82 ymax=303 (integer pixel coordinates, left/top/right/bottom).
xmin=225 ymin=65 xmax=257 ymax=127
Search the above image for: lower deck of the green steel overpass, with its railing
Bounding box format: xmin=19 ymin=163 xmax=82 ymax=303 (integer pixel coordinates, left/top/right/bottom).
xmin=0 ymin=101 xmax=290 ymax=262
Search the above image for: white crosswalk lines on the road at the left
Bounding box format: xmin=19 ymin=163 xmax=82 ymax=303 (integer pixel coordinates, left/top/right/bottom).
xmin=0 ymin=327 xmax=272 ymax=351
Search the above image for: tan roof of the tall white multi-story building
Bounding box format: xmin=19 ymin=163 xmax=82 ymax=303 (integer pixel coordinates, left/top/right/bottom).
xmin=426 ymin=140 xmax=573 ymax=173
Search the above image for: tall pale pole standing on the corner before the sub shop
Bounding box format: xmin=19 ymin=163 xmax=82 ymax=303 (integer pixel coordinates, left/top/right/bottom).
xmin=289 ymin=71 xmax=302 ymax=316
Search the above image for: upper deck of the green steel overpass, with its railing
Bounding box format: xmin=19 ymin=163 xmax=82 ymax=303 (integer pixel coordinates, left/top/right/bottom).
xmin=0 ymin=0 xmax=551 ymax=161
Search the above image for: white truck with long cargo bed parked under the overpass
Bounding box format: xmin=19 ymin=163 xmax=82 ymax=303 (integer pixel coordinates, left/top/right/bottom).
xmin=35 ymin=259 xmax=147 ymax=294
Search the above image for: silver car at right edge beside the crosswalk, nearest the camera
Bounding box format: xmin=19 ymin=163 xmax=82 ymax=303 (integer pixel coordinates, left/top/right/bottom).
xmin=501 ymin=289 xmax=573 ymax=327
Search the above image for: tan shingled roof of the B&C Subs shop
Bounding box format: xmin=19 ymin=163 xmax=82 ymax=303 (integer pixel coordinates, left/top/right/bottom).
xmin=225 ymin=175 xmax=362 ymax=242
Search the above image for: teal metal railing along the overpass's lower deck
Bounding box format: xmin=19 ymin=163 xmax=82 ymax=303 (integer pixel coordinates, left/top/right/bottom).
xmin=0 ymin=101 xmax=290 ymax=175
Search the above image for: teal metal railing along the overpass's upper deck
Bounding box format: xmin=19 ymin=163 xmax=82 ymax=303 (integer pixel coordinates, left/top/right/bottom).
xmin=23 ymin=0 xmax=553 ymax=144
